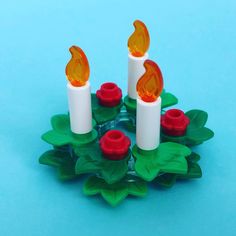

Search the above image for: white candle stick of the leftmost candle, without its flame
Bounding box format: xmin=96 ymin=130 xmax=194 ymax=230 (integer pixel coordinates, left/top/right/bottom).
xmin=67 ymin=81 xmax=92 ymax=134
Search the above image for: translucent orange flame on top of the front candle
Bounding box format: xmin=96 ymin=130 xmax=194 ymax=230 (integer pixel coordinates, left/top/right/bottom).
xmin=136 ymin=60 xmax=163 ymax=102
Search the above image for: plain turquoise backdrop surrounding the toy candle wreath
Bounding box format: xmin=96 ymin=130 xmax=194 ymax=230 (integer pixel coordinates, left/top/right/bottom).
xmin=0 ymin=0 xmax=236 ymax=236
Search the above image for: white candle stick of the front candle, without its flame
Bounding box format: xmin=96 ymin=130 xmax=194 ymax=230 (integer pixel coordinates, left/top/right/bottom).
xmin=136 ymin=97 xmax=161 ymax=151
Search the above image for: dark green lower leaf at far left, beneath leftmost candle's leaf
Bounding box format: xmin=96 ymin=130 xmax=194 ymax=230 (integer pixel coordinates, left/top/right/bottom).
xmin=39 ymin=150 xmax=78 ymax=180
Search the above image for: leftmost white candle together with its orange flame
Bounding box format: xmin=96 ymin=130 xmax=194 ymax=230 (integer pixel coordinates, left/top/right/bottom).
xmin=66 ymin=46 xmax=93 ymax=134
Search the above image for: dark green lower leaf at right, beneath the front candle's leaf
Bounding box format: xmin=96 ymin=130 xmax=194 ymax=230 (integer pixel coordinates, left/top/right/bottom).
xmin=154 ymin=152 xmax=202 ymax=188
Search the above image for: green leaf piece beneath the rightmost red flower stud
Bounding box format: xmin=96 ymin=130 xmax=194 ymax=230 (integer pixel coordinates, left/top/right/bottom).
xmin=161 ymin=110 xmax=214 ymax=146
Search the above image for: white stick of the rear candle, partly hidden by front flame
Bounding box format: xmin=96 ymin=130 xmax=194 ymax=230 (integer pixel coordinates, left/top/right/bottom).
xmin=128 ymin=53 xmax=148 ymax=99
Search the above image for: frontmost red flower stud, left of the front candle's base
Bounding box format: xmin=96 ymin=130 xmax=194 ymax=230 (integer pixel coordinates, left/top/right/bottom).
xmin=100 ymin=130 xmax=131 ymax=160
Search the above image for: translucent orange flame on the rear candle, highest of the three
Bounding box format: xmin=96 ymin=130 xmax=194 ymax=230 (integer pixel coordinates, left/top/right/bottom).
xmin=128 ymin=20 xmax=150 ymax=57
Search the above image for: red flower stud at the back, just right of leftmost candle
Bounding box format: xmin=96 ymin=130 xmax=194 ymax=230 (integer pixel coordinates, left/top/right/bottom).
xmin=96 ymin=82 xmax=122 ymax=107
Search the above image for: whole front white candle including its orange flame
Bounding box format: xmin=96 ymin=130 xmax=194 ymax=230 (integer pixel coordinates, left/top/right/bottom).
xmin=136 ymin=60 xmax=163 ymax=151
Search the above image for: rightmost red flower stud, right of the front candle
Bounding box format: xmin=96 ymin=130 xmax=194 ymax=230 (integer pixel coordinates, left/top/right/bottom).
xmin=161 ymin=109 xmax=190 ymax=136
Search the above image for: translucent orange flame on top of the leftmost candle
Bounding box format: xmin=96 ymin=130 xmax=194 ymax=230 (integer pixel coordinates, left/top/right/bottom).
xmin=66 ymin=46 xmax=90 ymax=87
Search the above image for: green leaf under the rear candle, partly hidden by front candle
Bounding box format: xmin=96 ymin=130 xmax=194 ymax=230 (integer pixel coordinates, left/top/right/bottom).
xmin=124 ymin=90 xmax=178 ymax=114
